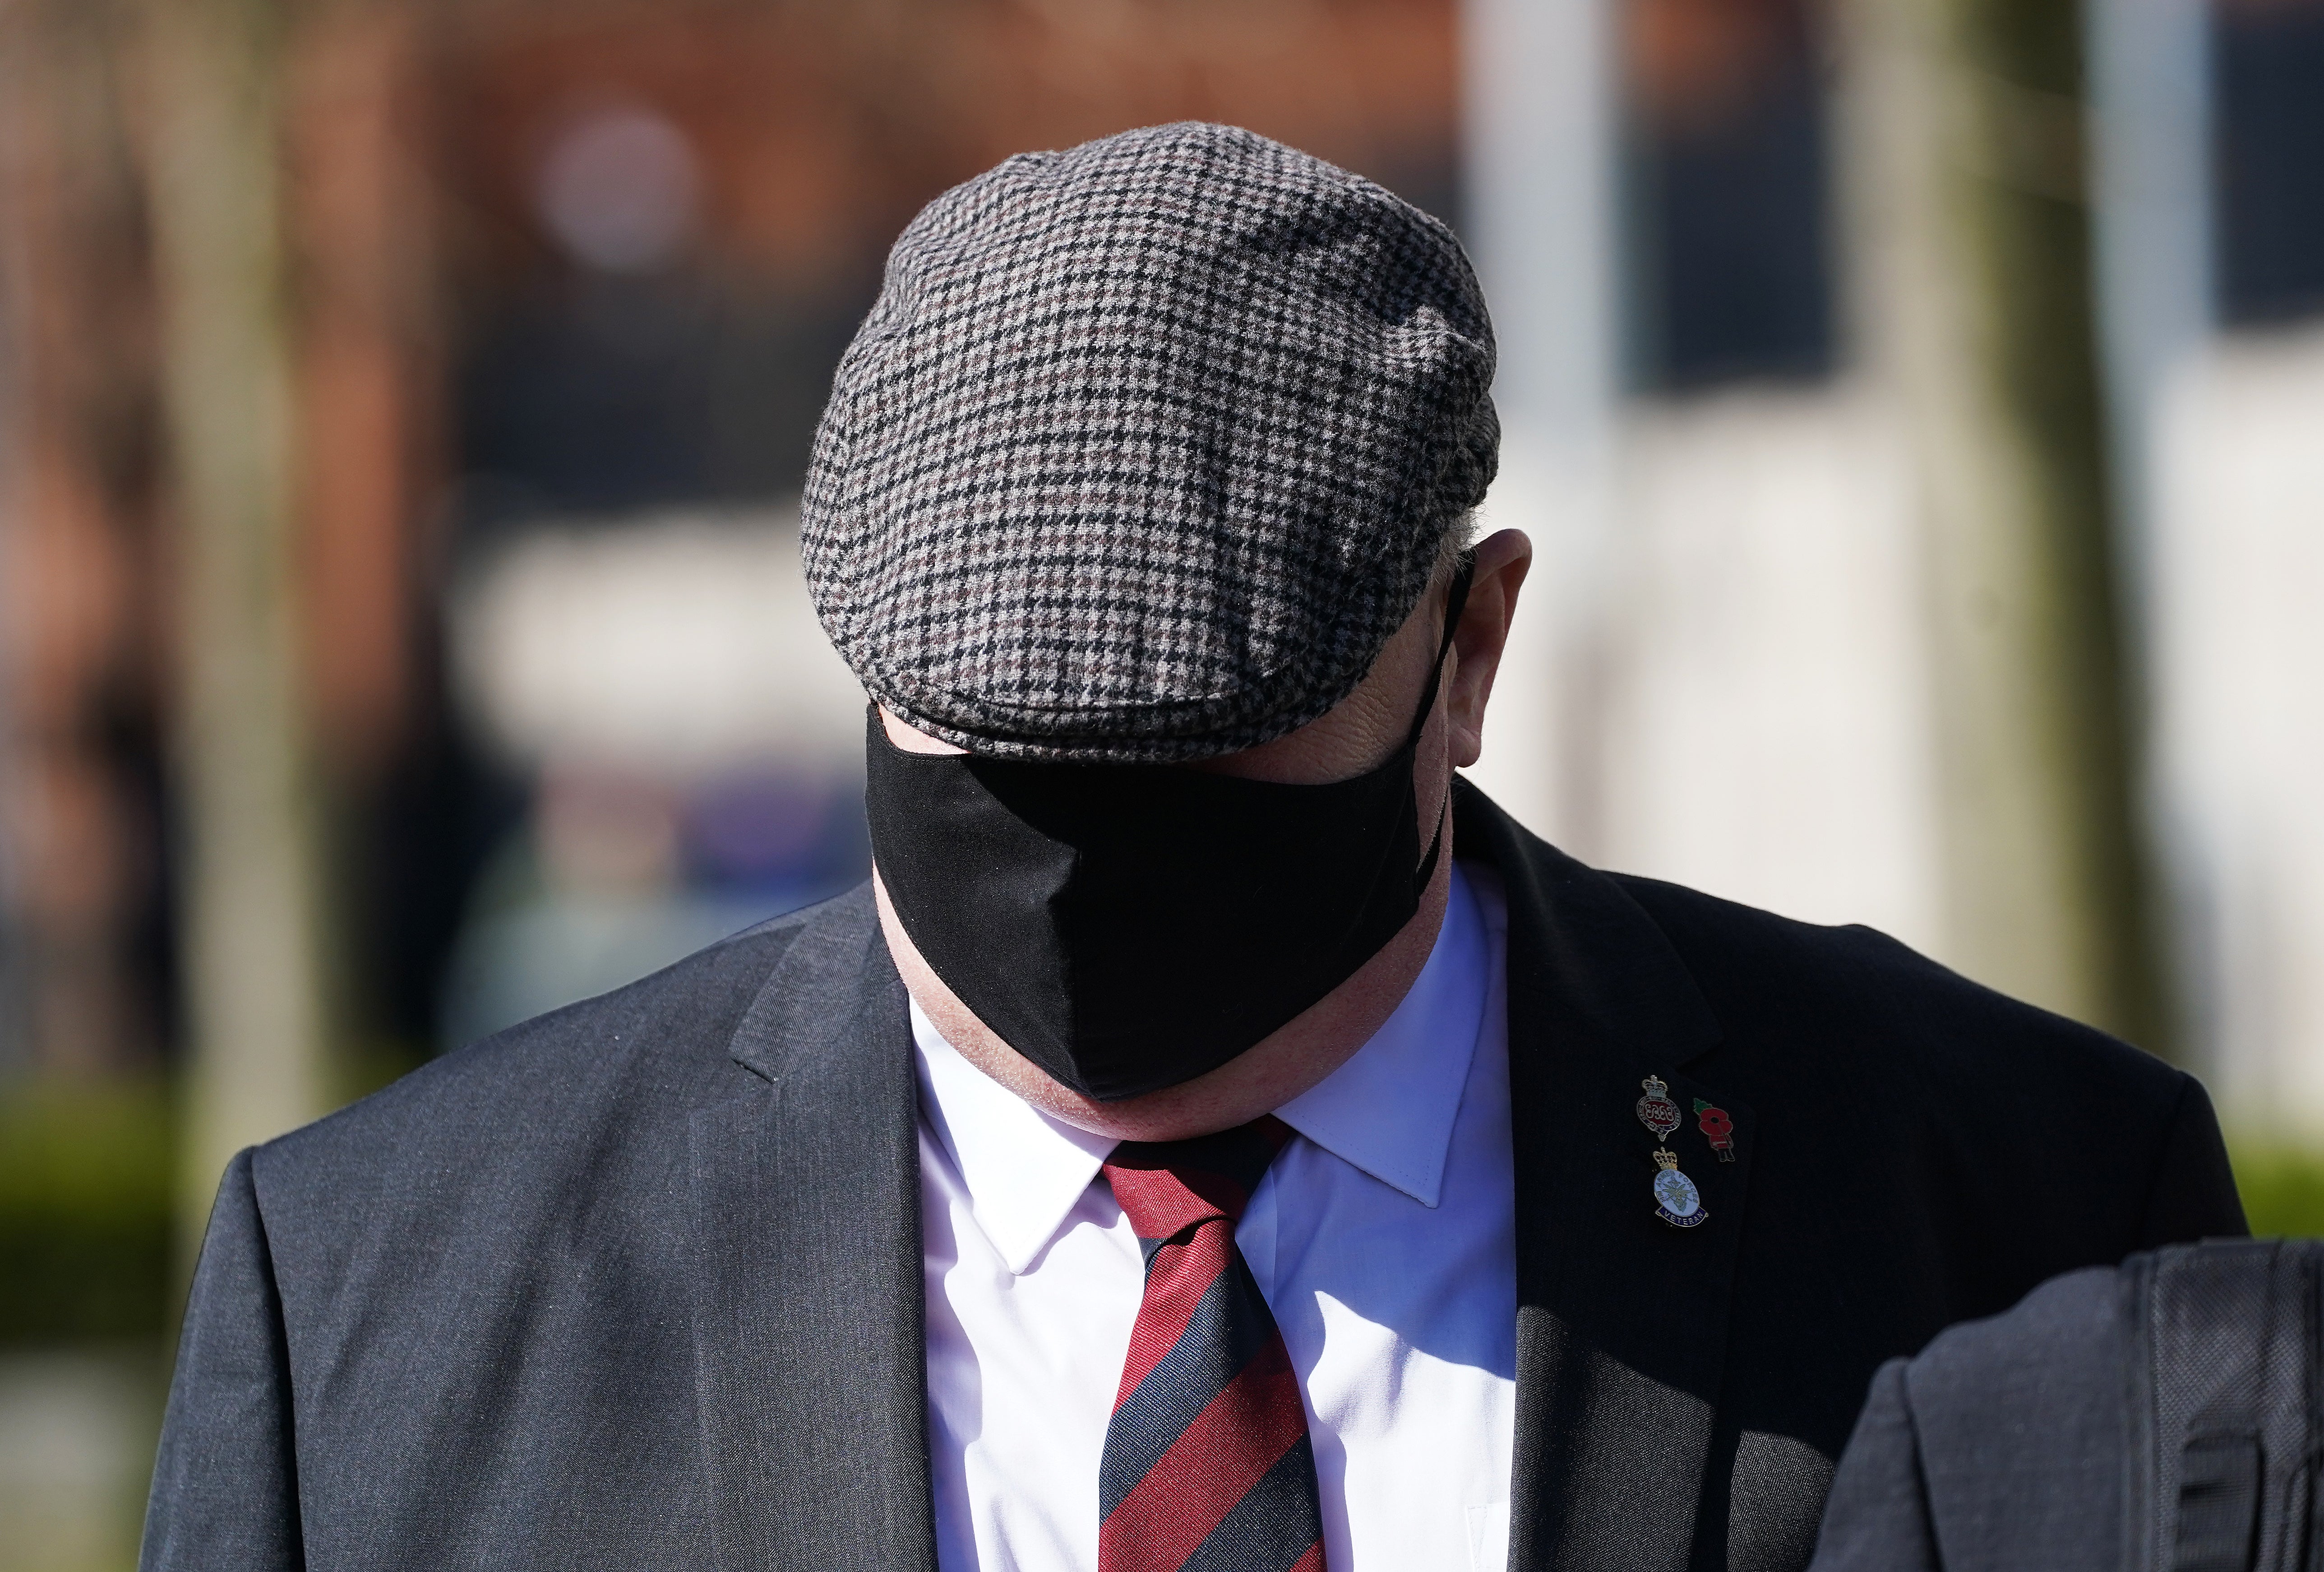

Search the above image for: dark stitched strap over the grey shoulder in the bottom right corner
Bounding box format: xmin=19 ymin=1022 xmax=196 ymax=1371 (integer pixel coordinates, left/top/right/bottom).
xmin=2124 ymin=1239 xmax=2319 ymax=1572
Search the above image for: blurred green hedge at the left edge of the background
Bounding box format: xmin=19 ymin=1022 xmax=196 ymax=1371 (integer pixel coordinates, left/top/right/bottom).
xmin=0 ymin=1079 xmax=174 ymax=1346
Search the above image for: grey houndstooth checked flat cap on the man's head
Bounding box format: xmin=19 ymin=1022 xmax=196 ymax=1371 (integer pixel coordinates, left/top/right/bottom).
xmin=802 ymin=123 xmax=1499 ymax=763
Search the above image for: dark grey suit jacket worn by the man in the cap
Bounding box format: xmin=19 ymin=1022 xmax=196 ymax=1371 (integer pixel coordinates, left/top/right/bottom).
xmin=144 ymin=786 xmax=2241 ymax=1572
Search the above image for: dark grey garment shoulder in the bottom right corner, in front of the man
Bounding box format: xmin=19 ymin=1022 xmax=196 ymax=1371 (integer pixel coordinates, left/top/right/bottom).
xmin=1813 ymin=1239 xmax=2324 ymax=1572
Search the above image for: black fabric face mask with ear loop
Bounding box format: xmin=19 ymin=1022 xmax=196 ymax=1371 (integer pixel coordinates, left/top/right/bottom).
xmin=864 ymin=570 xmax=1469 ymax=1102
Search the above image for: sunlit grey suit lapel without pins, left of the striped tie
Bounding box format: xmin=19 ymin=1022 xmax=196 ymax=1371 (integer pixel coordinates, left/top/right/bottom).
xmin=690 ymin=891 xmax=934 ymax=1572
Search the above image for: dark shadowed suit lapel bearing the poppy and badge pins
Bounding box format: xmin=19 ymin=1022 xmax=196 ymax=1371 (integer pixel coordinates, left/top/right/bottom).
xmin=1455 ymin=784 xmax=1757 ymax=1572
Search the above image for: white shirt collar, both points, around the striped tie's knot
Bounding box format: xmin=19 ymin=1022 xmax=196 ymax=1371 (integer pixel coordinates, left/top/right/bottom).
xmin=911 ymin=863 xmax=1490 ymax=1272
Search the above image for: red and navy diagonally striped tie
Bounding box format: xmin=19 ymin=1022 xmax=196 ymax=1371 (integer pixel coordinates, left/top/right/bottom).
xmin=1097 ymin=1114 xmax=1322 ymax=1572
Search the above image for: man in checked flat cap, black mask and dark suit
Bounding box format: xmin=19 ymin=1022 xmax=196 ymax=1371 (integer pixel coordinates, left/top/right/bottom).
xmin=147 ymin=125 xmax=2241 ymax=1572
